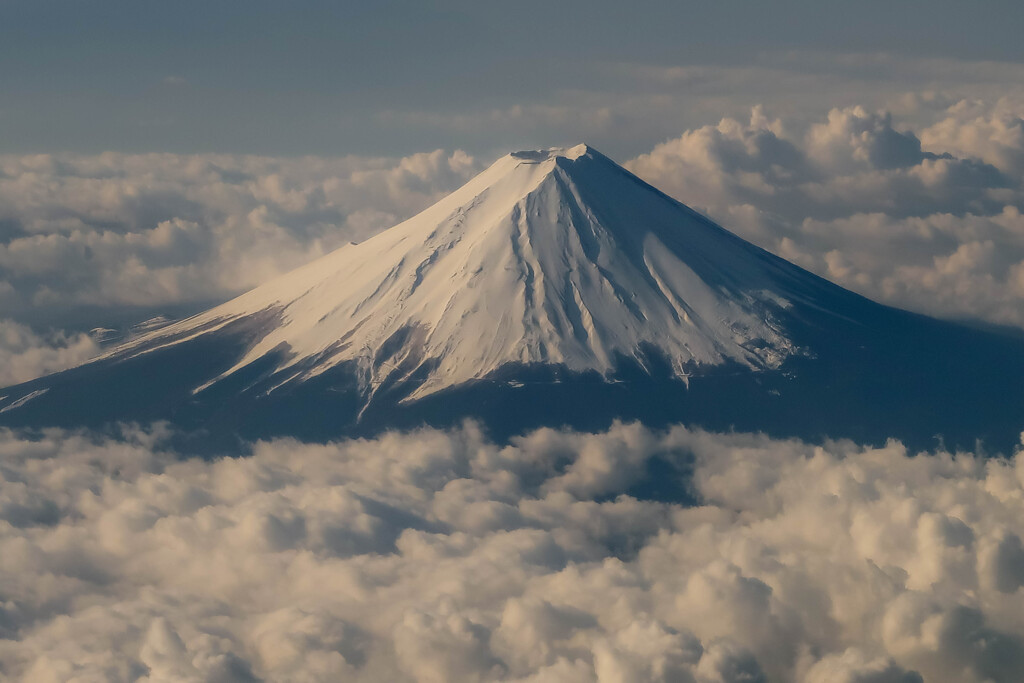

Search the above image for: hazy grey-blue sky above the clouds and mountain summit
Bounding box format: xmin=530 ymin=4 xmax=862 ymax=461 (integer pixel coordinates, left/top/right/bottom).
xmin=6 ymin=0 xmax=1024 ymax=157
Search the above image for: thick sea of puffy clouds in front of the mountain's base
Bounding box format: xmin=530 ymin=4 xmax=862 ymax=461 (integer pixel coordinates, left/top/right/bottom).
xmin=0 ymin=425 xmax=1024 ymax=683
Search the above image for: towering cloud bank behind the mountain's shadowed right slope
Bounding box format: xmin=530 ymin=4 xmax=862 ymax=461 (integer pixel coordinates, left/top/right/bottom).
xmin=628 ymin=99 xmax=1024 ymax=326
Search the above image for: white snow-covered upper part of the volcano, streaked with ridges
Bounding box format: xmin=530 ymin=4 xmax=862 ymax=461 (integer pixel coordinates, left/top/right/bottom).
xmin=113 ymin=144 xmax=806 ymax=399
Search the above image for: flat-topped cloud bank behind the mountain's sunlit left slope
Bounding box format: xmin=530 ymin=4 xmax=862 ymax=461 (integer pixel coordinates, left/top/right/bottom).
xmin=0 ymin=151 xmax=479 ymax=321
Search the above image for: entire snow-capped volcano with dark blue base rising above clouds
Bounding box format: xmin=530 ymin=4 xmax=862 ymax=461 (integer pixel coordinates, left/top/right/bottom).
xmin=0 ymin=145 xmax=1024 ymax=451
